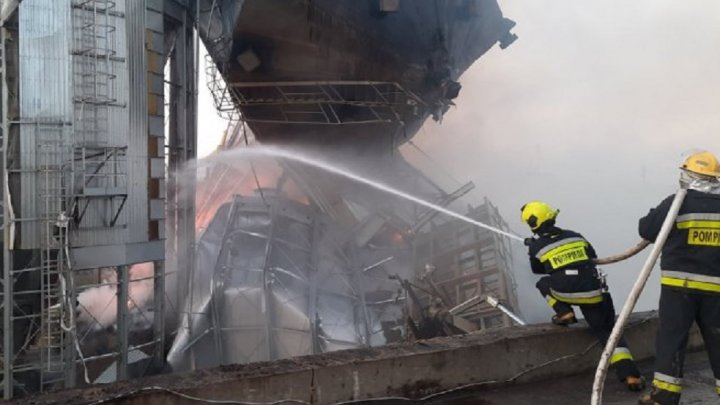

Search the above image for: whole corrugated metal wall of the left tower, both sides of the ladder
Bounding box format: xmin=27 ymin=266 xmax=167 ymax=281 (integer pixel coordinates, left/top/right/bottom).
xmin=13 ymin=0 xmax=152 ymax=248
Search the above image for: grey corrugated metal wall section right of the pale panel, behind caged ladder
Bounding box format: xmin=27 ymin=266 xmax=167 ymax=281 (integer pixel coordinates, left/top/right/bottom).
xmin=72 ymin=0 xmax=147 ymax=247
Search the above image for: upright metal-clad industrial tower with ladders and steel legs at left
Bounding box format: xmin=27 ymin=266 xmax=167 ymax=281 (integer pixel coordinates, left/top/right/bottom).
xmin=0 ymin=0 xmax=197 ymax=398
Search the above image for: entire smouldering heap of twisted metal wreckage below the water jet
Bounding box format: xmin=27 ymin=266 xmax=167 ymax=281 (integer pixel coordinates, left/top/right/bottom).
xmin=168 ymin=109 xmax=517 ymax=370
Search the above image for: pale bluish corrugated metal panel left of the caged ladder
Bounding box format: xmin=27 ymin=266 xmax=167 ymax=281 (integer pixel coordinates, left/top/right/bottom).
xmin=17 ymin=0 xmax=73 ymax=248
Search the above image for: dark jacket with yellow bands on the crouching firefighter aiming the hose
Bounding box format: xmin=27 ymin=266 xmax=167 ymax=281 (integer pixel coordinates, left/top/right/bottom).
xmin=528 ymin=226 xmax=603 ymax=304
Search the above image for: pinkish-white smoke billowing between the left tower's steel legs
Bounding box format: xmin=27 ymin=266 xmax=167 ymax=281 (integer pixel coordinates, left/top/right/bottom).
xmin=77 ymin=262 xmax=155 ymax=330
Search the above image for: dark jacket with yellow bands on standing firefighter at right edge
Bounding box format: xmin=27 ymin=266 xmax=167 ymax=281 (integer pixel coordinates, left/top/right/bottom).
xmin=638 ymin=190 xmax=720 ymax=294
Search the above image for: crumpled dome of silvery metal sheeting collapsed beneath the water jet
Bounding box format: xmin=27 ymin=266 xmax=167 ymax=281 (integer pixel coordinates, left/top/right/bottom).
xmin=167 ymin=193 xmax=384 ymax=371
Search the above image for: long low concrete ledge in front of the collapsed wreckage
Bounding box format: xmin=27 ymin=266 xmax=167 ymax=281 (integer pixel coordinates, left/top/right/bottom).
xmin=19 ymin=312 xmax=702 ymax=404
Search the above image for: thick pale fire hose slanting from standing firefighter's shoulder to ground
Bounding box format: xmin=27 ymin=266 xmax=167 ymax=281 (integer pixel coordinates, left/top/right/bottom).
xmin=590 ymin=188 xmax=687 ymax=405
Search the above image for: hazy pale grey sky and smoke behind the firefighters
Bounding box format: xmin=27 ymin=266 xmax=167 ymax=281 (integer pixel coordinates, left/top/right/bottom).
xmin=404 ymin=0 xmax=720 ymax=318
